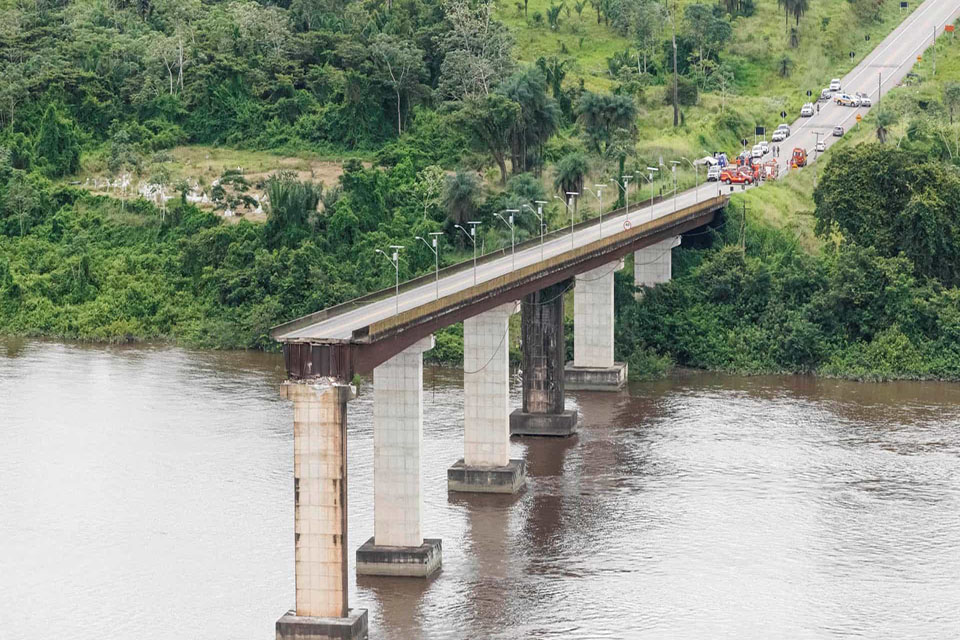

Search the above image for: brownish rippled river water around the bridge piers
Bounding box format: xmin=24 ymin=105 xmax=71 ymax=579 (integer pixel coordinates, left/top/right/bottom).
xmin=0 ymin=340 xmax=960 ymax=640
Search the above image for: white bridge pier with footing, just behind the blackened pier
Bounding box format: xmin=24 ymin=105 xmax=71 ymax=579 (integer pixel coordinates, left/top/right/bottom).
xmin=566 ymin=260 xmax=627 ymax=391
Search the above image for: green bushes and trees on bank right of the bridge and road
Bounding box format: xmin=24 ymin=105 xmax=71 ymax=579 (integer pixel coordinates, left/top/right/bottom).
xmin=617 ymin=28 xmax=960 ymax=379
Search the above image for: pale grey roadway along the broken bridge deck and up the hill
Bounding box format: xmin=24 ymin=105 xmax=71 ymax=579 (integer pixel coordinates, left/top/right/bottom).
xmin=275 ymin=0 xmax=960 ymax=342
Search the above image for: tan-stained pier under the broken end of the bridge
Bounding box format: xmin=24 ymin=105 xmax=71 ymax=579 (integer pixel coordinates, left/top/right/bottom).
xmin=276 ymin=378 xmax=367 ymax=640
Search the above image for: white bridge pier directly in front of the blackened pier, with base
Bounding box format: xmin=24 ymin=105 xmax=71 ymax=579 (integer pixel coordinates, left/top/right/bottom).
xmin=447 ymin=302 xmax=526 ymax=493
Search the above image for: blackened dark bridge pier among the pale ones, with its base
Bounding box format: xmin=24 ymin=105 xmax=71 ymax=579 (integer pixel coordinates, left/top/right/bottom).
xmin=510 ymin=280 xmax=578 ymax=436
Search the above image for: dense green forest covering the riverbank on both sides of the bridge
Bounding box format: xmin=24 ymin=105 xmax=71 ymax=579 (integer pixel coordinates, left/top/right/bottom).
xmin=0 ymin=0 xmax=960 ymax=377
